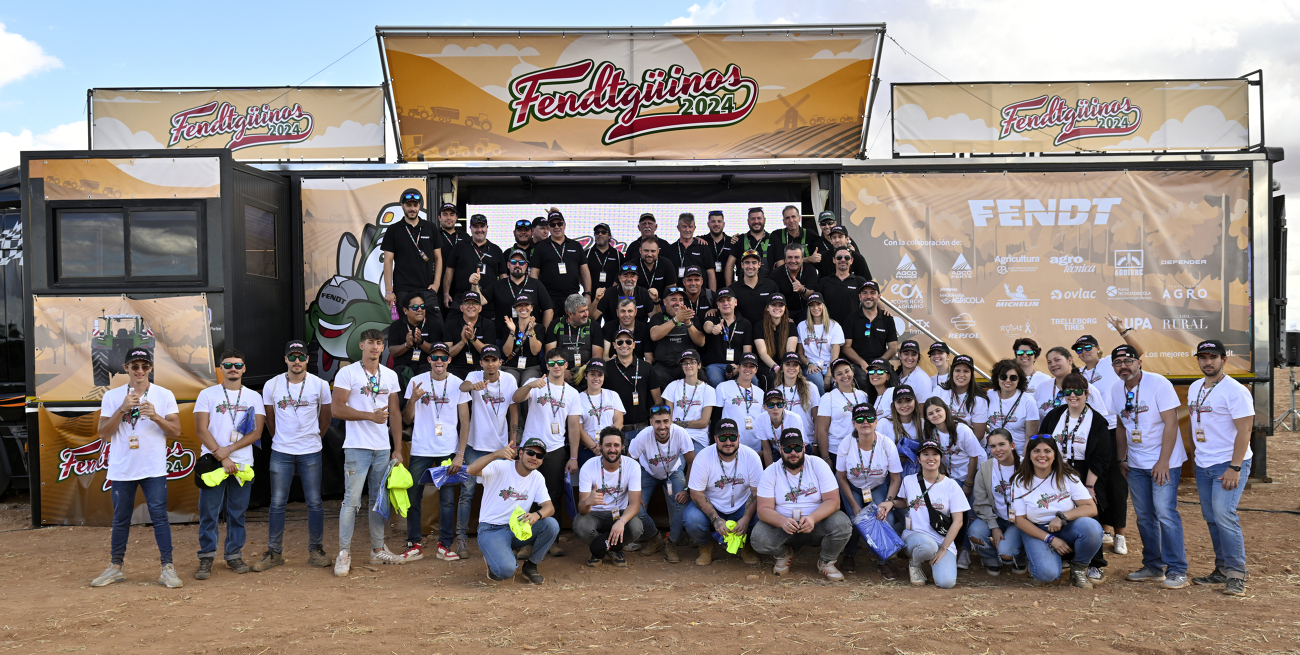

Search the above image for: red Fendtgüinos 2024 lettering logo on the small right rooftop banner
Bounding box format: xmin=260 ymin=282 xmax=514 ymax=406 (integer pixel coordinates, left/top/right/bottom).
xmin=997 ymin=96 xmax=1141 ymax=146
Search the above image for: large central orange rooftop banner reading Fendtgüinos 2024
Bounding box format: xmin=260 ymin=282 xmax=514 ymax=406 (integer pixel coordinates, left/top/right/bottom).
xmin=380 ymin=26 xmax=884 ymax=161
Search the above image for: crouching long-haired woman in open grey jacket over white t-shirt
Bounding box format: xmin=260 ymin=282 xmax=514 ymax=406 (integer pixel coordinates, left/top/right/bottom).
xmin=966 ymin=426 xmax=1024 ymax=576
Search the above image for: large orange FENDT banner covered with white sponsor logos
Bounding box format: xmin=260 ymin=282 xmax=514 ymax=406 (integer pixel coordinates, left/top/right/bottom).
xmin=842 ymin=170 xmax=1251 ymax=376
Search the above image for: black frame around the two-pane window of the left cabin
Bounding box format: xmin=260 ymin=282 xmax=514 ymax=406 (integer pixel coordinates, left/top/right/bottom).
xmin=46 ymin=199 xmax=208 ymax=289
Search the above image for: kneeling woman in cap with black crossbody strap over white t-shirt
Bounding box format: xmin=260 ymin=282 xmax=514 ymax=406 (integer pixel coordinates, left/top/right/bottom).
xmin=898 ymin=441 xmax=970 ymax=589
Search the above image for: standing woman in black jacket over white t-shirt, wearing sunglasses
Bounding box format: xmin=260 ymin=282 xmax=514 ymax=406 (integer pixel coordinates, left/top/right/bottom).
xmin=1043 ymin=373 xmax=1127 ymax=582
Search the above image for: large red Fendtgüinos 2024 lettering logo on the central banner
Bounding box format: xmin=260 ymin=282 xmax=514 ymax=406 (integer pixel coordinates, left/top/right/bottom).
xmin=510 ymin=60 xmax=758 ymax=146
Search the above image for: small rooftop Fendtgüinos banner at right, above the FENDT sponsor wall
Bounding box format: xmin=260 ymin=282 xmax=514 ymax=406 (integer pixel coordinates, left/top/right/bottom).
xmin=893 ymin=79 xmax=1251 ymax=155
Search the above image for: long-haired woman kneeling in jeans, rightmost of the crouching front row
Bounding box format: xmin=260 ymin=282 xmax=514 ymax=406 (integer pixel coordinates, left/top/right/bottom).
xmin=1011 ymin=434 xmax=1101 ymax=589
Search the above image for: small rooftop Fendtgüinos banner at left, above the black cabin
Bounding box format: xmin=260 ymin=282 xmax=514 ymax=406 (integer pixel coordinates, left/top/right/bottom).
xmin=91 ymin=87 xmax=385 ymax=161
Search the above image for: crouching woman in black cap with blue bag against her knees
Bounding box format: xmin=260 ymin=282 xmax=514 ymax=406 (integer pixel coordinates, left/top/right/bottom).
xmin=835 ymin=403 xmax=902 ymax=580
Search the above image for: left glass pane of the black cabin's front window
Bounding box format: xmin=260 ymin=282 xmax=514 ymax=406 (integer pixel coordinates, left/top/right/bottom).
xmin=59 ymin=212 xmax=126 ymax=278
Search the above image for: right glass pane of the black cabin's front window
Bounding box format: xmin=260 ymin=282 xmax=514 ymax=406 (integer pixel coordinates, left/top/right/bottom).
xmin=130 ymin=209 xmax=199 ymax=277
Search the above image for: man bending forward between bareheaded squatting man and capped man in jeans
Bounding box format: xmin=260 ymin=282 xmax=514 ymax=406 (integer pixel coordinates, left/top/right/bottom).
xmin=628 ymin=404 xmax=696 ymax=564
